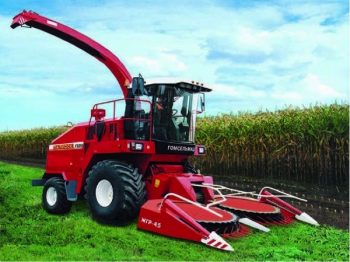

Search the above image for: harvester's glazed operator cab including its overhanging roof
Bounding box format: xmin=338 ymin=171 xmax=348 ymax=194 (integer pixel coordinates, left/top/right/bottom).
xmin=145 ymin=82 xmax=210 ymax=143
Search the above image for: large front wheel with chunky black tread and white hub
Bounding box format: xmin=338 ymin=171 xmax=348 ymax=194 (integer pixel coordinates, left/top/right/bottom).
xmin=85 ymin=160 xmax=146 ymax=225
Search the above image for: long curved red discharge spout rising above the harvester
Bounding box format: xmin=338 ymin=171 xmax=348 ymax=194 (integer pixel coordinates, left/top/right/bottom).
xmin=11 ymin=10 xmax=132 ymax=97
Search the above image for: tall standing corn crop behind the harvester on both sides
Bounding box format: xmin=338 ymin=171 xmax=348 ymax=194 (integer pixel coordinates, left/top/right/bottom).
xmin=0 ymin=104 xmax=349 ymax=188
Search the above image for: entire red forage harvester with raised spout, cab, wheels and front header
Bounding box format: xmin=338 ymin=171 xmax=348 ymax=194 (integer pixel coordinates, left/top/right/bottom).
xmin=11 ymin=11 xmax=318 ymax=251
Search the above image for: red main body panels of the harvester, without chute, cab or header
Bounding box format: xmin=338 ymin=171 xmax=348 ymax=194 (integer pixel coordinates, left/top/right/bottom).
xmin=45 ymin=113 xmax=200 ymax=195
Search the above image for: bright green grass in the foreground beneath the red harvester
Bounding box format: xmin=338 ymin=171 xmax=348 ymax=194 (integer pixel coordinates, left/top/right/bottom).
xmin=0 ymin=162 xmax=349 ymax=261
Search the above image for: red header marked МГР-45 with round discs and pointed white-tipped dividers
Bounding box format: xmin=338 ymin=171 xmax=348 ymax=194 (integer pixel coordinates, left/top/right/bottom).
xmin=138 ymin=179 xmax=318 ymax=251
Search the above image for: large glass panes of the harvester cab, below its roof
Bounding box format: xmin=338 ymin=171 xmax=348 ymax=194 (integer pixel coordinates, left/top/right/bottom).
xmin=153 ymin=85 xmax=197 ymax=142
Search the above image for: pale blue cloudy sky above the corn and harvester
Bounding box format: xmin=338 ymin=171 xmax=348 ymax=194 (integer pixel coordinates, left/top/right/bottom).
xmin=0 ymin=0 xmax=349 ymax=131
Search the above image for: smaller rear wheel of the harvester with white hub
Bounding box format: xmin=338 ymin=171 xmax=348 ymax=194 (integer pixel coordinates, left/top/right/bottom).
xmin=42 ymin=177 xmax=72 ymax=214
